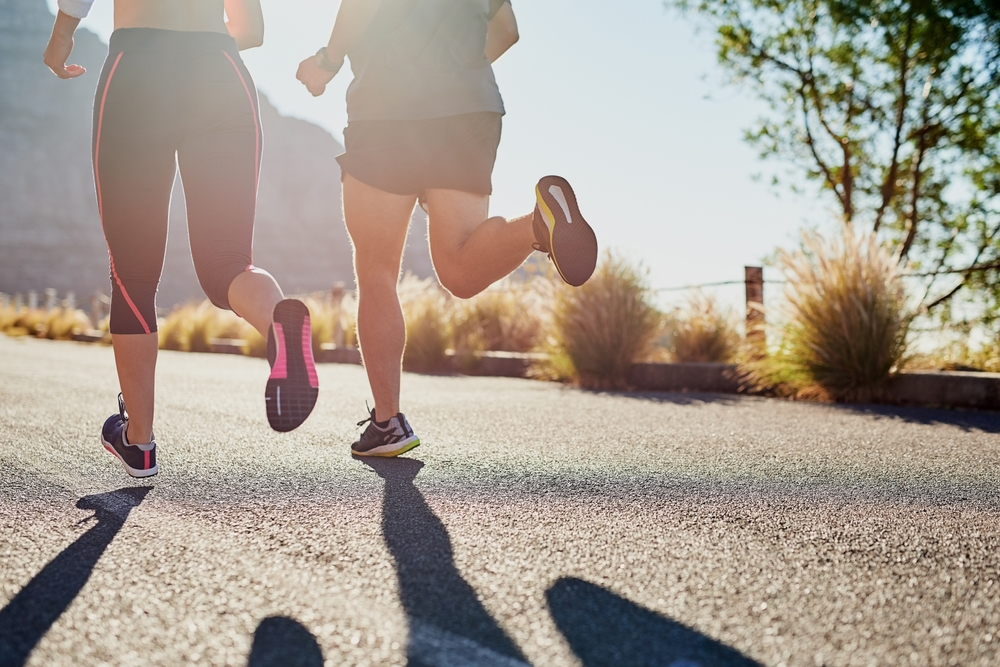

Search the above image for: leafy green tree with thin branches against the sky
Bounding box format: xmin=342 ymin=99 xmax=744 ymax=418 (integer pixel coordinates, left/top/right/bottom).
xmin=666 ymin=0 xmax=1000 ymax=324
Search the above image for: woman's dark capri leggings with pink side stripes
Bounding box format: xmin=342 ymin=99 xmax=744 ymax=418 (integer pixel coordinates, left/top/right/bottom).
xmin=93 ymin=28 xmax=261 ymax=334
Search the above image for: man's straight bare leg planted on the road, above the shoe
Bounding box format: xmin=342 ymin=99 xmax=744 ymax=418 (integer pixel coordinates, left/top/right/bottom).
xmin=343 ymin=173 xmax=417 ymax=421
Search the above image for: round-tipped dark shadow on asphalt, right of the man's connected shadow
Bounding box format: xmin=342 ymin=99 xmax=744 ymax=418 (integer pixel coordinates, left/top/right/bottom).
xmin=545 ymin=577 xmax=760 ymax=667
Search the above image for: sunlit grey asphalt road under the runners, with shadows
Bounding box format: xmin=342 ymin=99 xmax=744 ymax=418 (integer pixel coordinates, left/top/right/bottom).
xmin=0 ymin=336 xmax=1000 ymax=667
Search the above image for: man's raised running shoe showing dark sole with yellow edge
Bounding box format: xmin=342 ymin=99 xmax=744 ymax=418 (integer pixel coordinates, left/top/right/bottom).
xmin=532 ymin=176 xmax=597 ymax=287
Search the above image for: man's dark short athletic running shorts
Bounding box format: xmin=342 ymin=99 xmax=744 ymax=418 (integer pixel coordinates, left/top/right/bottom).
xmin=337 ymin=111 xmax=502 ymax=195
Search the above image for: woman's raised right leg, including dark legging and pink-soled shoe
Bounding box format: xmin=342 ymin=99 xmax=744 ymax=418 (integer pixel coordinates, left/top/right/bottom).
xmin=177 ymin=51 xmax=319 ymax=431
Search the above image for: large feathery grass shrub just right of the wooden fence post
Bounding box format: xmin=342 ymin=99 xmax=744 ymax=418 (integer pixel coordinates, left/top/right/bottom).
xmin=746 ymin=229 xmax=910 ymax=401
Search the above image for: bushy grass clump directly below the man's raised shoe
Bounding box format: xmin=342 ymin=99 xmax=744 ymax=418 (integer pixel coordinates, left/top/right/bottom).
xmin=536 ymin=253 xmax=661 ymax=388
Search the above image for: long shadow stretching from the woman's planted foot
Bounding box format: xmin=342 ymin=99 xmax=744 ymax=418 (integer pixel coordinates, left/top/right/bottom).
xmin=0 ymin=486 xmax=153 ymax=667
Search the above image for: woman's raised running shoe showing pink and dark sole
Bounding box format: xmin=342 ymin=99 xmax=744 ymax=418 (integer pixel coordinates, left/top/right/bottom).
xmin=264 ymin=299 xmax=319 ymax=432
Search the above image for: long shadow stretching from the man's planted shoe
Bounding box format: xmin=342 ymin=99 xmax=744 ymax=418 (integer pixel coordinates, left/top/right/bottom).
xmin=362 ymin=458 xmax=527 ymax=667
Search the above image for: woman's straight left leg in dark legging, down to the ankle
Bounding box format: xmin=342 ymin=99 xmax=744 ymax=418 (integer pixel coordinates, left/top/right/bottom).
xmin=93 ymin=52 xmax=176 ymax=444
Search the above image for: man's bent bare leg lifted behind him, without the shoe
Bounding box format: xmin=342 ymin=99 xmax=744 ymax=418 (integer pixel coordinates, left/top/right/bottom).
xmin=427 ymin=190 xmax=535 ymax=299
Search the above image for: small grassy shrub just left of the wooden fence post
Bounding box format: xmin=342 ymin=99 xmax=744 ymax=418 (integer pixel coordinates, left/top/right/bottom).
xmin=662 ymin=292 xmax=740 ymax=363
